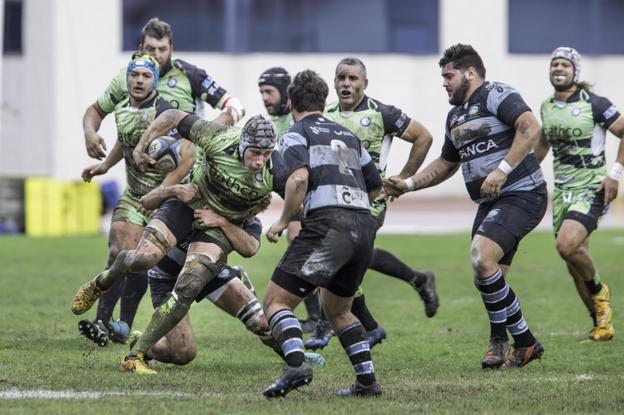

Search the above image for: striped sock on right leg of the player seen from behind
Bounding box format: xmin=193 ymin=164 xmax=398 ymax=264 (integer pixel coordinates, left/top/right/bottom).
xmin=338 ymin=323 xmax=375 ymax=386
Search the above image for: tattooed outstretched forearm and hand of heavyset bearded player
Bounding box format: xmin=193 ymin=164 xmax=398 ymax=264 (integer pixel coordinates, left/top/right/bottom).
xmin=384 ymin=157 xmax=460 ymax=197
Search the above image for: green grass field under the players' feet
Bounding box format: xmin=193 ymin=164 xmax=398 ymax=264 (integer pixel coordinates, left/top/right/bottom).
xmin=0 ymin=231 xmax=624 ymax=415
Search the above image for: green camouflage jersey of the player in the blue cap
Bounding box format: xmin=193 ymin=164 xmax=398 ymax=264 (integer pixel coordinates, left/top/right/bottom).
xmin=114 ymin=93 xmax=171 ymax=197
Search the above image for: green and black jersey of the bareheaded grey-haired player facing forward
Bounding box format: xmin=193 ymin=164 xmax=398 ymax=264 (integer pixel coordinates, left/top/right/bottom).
xmin=325 ymin=95 xmax=411 ymax=176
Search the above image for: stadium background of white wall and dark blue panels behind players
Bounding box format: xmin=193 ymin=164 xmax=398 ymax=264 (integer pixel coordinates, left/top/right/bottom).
xmin=0 ymin=0 xmax=624 ymax=234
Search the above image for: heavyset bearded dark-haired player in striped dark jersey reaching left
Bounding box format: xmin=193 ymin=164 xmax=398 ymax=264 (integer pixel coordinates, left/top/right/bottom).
xmin=384 ymin=44 xmax=547 ymax=368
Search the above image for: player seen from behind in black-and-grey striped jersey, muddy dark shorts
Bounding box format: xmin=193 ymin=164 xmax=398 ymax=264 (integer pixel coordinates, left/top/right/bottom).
xmin=263 ymin=70 xmax=382 ymax=398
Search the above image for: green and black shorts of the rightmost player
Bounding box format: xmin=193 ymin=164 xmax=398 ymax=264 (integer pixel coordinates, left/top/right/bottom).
xmin=553 ymin=188 xmax=609 ymax=235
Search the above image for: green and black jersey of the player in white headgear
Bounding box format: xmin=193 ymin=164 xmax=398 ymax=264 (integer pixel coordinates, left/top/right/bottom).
xmin=540 ymin=89 xmax=620 ymax=190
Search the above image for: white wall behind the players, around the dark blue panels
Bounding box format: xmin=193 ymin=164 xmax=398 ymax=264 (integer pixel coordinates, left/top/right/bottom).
xmin=0 ymin=0 xmax=624 ymax=195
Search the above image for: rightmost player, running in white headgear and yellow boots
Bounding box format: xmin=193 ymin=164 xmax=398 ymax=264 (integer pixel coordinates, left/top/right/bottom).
xmin=535 ymin=47 xmax=624 ymax=341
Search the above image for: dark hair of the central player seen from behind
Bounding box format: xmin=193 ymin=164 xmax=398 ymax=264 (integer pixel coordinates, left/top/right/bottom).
xmin=288 ymin=69 xmax=329 ymax=112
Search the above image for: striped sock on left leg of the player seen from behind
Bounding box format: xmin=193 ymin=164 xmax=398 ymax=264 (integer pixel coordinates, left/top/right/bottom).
xmin=269 ymin=309 xmax=305 ymax=367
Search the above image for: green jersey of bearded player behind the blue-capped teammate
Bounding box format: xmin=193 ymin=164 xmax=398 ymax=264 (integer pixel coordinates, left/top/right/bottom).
xmin=97 ymin=59 xmax=231 ymax=113
